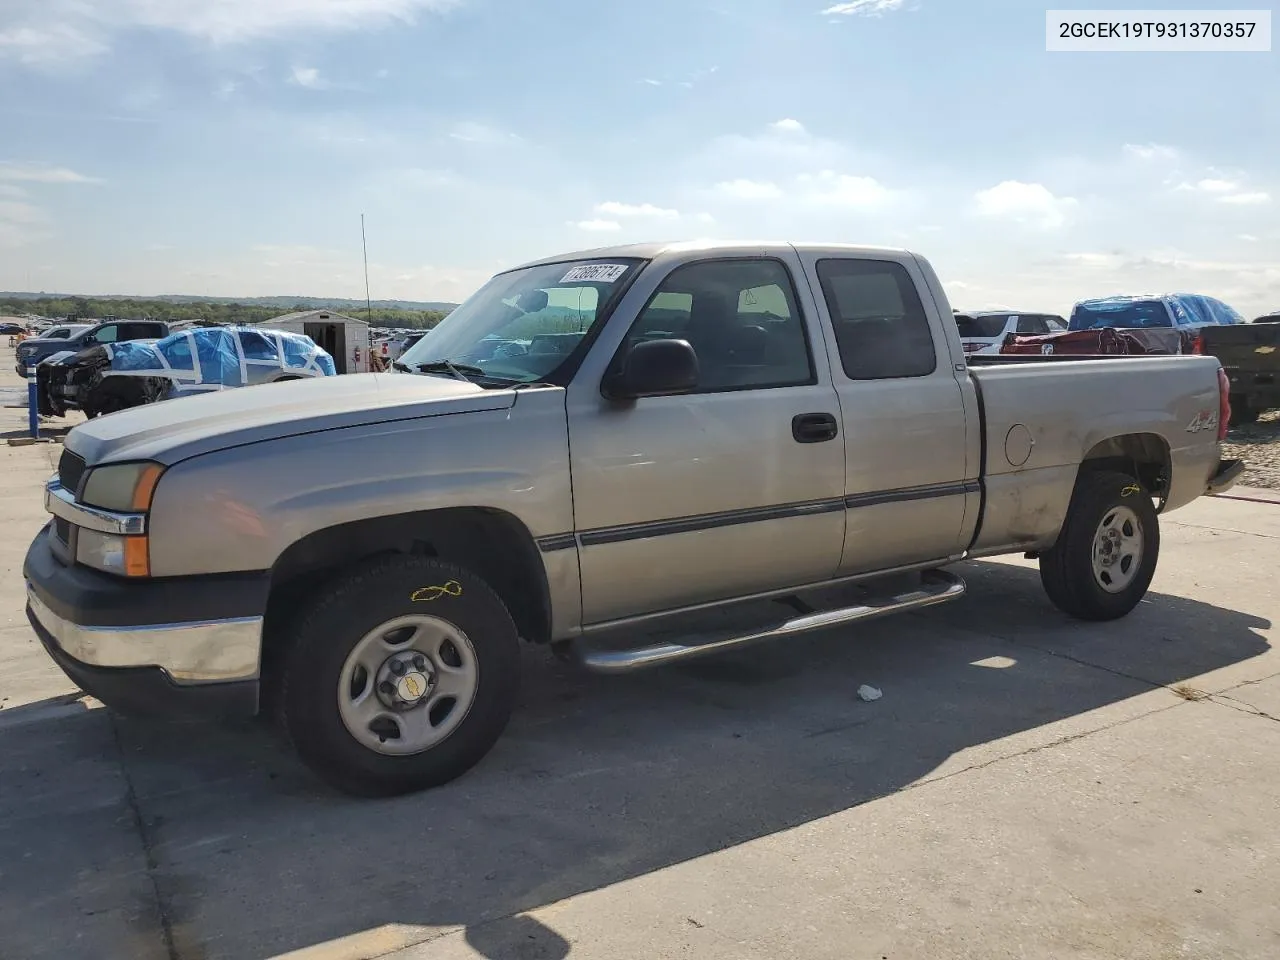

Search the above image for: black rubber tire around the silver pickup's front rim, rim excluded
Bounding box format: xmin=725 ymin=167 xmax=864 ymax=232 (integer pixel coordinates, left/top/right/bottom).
xmin=279 ymin=557 xmax=520 ymax=797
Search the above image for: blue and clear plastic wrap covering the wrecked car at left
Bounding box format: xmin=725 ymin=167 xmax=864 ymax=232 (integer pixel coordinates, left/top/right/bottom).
xmin=104 ymin=326 xmax=338 ymax=396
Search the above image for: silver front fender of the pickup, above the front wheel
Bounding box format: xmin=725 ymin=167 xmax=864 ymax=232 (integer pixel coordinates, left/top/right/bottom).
xmin=144 ymin=390 xmax=573 ymax=576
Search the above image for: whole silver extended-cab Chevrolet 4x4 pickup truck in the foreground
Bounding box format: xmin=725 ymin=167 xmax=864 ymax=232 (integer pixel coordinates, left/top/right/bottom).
xmin=17 ymin=243 xmax=1243 ymax=795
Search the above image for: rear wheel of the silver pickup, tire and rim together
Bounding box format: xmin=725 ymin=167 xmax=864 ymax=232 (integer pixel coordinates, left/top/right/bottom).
xmin=1039 ymin=471 xmax=1160 ymax=621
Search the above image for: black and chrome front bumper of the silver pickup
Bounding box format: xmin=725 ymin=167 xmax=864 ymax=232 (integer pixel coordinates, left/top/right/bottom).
xmin=23 ymin=524 xmax=269 ymax=718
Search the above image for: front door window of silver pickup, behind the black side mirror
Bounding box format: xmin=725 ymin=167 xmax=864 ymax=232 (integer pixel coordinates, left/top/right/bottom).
xmin=626 ymin=260 xmax=817 ymax=393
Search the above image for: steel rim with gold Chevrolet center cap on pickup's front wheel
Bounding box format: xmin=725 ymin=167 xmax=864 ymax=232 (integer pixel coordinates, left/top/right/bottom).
xmin=337 ymin=614 xmax=480 ymax=756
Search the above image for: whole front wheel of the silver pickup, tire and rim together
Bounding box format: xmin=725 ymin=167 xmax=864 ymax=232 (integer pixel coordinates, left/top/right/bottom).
xmin=280 ymin=557 xmax=520 ymax=796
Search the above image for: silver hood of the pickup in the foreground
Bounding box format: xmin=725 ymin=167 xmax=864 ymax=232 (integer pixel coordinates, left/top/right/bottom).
xmin=65 ymin=374 xmax=516 ymax=466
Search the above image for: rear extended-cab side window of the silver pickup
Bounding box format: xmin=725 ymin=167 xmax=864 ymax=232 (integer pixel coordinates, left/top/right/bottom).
xmin=818 ymin=260 xmax=938 ymax=380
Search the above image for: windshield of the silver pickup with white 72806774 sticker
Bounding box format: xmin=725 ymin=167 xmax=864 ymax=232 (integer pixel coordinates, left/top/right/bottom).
xmin=398 ymin=259 xmax=641 ymax=385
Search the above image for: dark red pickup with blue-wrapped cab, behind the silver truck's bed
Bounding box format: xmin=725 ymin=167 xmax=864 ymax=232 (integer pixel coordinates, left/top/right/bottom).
xmin=1000 ymin=293 xmax=1244 ymax=355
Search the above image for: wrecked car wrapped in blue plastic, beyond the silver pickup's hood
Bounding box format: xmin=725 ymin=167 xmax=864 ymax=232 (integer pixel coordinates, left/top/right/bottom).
xmin=36 ymin=326 xmax=337 ymax=419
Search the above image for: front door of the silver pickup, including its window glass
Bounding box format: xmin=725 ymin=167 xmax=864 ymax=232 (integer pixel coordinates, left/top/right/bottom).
xmin=567 ymin=251 xmax=845 ymax=625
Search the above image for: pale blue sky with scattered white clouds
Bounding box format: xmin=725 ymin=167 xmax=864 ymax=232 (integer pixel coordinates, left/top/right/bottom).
xmin=0 ymin=0 xmax=1280 ymax=317
